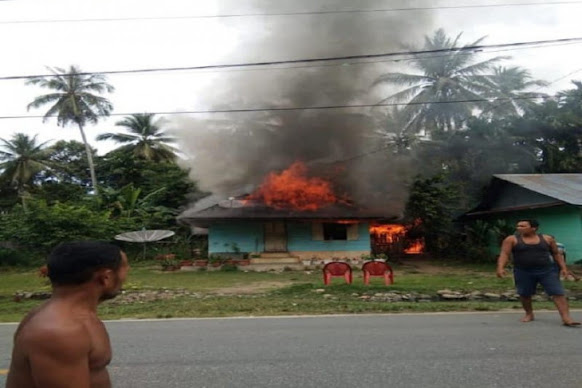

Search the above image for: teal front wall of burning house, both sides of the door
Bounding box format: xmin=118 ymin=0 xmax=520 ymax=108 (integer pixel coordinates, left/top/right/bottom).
xmin=208 ymin=221 xmax=370 ymax=254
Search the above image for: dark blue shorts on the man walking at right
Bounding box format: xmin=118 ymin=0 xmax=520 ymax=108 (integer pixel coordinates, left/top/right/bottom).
xmin=513 ymin=265 xmax=564 ymax=296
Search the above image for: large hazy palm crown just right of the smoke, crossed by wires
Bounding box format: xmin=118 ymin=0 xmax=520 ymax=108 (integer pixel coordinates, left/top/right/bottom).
xmin=374 ymin=29 xmax=505 ymax=131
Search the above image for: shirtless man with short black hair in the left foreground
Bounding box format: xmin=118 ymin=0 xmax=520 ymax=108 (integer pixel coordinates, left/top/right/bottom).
xmin=6 ymin=242 xmax=129 ymax=388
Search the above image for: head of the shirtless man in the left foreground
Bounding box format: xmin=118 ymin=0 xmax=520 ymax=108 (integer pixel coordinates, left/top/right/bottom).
xmin=47 ymin=241 xmax=129 ymax=300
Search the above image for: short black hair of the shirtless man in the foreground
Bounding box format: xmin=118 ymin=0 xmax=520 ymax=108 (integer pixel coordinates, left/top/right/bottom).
xmin=47 ymin=241 xmax=121 ymax=285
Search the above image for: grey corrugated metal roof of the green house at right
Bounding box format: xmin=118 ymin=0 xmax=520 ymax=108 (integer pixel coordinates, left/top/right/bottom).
xmin=494 ymin=174 xmax=582 ymax=206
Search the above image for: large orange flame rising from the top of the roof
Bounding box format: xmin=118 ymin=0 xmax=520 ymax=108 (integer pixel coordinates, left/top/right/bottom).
xmin=246 ymin=162 xmax=342 ymax=211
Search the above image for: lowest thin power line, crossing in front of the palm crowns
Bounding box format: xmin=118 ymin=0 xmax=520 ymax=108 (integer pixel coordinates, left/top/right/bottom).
xmin=0 ymin=94 xmax=549 ymax=119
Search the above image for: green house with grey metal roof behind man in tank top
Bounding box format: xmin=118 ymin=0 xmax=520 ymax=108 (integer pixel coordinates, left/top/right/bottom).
xmin=462 ymin=174 xmax=582 ymax=263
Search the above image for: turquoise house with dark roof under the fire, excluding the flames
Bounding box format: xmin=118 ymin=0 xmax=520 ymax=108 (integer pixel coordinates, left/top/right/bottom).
xmin=178 ymin=195 xmax=397 ymax=260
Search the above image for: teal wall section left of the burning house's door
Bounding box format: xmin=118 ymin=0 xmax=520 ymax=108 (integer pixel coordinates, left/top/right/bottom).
xmin=208 ymin=222 xmax=264 ymax=254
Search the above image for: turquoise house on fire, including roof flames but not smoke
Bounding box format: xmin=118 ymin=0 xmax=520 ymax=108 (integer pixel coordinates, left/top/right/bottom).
xmin=180 ymin=162 xmax=420 ymax=261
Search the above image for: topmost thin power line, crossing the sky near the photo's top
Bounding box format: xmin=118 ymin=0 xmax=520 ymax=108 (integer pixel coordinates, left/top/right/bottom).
xmin=0 ymin=1 xmax=582 ymax=24
